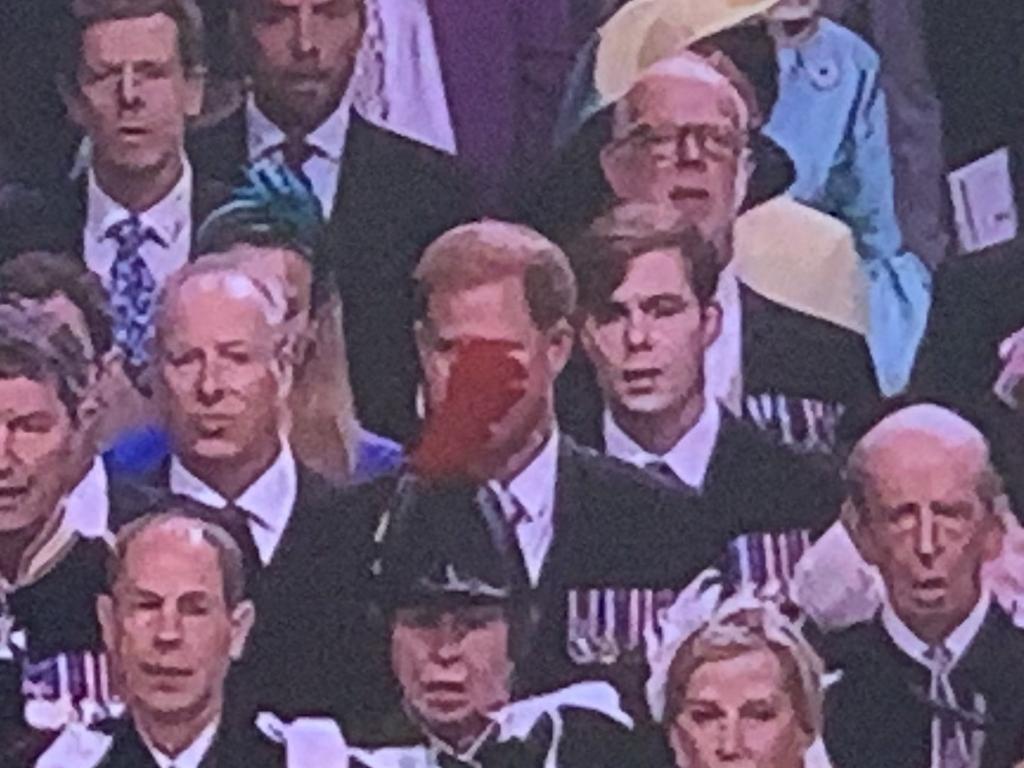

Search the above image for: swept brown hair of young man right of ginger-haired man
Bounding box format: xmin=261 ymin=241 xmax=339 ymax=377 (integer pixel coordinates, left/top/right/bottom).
xmin=569 ymin=203 xmax=721 ymax=315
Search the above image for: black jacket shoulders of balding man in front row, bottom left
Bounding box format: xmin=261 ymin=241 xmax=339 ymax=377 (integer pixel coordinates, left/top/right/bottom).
xmin=96 ymin=720 xmax=284 ymax=768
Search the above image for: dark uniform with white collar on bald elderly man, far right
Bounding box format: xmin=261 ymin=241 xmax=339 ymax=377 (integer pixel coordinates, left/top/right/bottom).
xmin=822 ymin=600 xmax=1024 ymax=768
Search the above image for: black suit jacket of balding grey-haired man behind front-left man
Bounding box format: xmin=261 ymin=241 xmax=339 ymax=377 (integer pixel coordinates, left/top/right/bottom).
xmin=112 ymin=465 xmax=378 ymax=723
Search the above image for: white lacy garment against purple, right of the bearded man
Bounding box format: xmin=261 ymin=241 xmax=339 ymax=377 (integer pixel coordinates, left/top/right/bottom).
xmin=353 ymin=0 xmax=456 ymax=155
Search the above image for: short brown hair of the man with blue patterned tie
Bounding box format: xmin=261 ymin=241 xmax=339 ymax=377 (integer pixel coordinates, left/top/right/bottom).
xmin=57 ymin=0 xmax=206 ymax=91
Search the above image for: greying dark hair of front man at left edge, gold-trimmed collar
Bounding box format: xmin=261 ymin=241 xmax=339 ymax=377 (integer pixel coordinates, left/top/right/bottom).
xmin=0 ymin=305 xmax=89 ymax=420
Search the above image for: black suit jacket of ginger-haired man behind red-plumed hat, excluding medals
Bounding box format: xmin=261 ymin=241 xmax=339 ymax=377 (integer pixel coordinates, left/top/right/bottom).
xmin=348 ymin=438 xmax=718 ymax=743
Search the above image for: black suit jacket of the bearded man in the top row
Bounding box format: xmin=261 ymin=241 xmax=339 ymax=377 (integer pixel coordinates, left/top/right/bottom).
xmin=189 ymin=110 xmax=476 ymax=440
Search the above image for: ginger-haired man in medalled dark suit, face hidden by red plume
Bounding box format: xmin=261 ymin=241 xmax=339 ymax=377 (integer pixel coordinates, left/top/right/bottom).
xmin=360 ymin=221 xmax=717 ymax=720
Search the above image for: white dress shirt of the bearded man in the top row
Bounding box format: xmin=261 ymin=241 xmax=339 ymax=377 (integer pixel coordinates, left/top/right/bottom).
xmin=246 ymin=88 xmax=352 ymax=218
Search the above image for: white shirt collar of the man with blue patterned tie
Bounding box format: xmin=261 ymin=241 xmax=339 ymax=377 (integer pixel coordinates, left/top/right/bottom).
xmin=86 ymin=158 xmax=193 ymax=248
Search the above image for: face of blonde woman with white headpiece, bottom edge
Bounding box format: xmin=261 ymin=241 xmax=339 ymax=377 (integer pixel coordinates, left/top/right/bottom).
xmin=669 ymin=649 xmax=811 ymax=768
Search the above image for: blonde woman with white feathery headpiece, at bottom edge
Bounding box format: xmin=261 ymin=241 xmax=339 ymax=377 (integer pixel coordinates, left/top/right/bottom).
xmin=647 ymin=575 xmax=828 ymax=768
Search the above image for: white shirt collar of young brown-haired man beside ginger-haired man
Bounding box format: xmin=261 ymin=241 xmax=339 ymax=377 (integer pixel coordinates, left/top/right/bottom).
xmin=604 ymin=399 xmax=722 ymax=489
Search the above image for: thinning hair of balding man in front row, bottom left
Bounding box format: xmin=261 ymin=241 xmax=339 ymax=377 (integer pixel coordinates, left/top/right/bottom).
xmin=106 ymin=507 xmax=246 ymax=609
